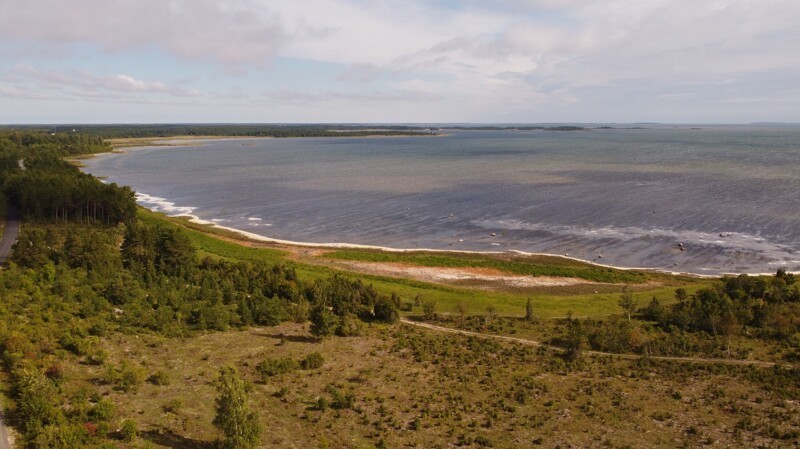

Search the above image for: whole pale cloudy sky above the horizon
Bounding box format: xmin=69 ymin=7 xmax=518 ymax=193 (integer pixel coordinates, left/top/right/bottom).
xmin=0 ymin=0 xmax=800 ymax=124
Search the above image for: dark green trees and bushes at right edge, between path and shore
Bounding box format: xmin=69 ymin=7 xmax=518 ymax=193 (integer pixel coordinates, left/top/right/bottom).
xmin=564 ymin=270 xmax=800 ymax=361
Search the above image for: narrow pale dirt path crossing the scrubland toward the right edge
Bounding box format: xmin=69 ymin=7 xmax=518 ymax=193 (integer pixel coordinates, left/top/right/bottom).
xmin=400 ymin=318 xmax=792 ymax=368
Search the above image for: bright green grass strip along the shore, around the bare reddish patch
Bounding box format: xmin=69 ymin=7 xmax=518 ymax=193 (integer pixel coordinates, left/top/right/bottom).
xmin=140 ymin=211 xmax=710 ymax=318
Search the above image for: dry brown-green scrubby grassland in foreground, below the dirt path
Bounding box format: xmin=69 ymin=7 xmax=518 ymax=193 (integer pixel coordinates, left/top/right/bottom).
xmin=53 ymin=324 xmax=800 ymax=448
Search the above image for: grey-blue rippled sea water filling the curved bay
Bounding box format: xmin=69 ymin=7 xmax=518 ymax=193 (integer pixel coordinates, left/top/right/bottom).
xmin=85 ymin=126 xmax=800 ymax=274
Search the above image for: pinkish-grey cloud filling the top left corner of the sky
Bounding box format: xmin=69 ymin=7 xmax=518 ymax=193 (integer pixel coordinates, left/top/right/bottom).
xmin=0 ymin=0 xmax=281 ymax=64
